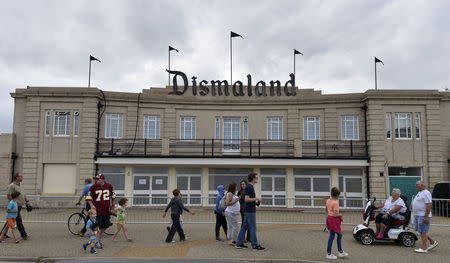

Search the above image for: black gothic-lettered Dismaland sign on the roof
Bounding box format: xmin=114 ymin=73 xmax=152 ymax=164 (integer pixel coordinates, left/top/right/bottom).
xmin=167 ymin=70 xmax=297 ymax=97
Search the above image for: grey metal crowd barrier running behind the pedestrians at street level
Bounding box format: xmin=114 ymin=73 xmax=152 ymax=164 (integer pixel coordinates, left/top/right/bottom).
xmin=0 ymin=196 xmax=450 ymax=226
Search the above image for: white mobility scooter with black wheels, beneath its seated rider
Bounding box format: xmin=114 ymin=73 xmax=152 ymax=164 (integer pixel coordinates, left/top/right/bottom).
xmin=353 ymin=191 xmax=417 ymax=247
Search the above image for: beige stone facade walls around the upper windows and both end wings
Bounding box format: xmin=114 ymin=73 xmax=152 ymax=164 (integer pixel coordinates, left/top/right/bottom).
xmin=8 ymin=87 xmax=450 ymax=196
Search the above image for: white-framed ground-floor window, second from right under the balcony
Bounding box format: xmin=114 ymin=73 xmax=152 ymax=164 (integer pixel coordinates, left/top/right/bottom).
xmin=294 ymin=168 xmax=331 ymax=207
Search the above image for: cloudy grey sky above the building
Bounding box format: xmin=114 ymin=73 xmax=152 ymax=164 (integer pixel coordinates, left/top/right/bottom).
xmin=0 ymin=0 xmax=450 ymax=133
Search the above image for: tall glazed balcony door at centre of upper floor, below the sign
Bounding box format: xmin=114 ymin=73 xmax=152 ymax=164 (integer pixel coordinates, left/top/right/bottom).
xmin=223 ymin=118 xmax=241 ymax=153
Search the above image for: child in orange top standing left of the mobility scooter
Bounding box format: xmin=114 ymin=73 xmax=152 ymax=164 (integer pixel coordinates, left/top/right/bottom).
xmin=326 ymin=187 xmax=348 ymax=259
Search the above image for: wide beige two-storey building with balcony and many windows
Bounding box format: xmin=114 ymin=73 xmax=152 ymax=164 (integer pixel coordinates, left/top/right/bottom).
xmin=7 ymin=83 xmax=450 ymax=207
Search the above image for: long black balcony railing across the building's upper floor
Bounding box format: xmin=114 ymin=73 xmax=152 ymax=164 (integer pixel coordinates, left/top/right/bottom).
xmin=97 ymin=138 xmax=367 ymax=158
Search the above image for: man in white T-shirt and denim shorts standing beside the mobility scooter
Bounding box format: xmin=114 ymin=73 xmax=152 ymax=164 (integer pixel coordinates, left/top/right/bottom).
xmin=411 ymin=181 xmax=439 ymax=253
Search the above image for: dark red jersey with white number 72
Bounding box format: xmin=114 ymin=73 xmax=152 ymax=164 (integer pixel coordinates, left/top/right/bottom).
xmin=86 ymin=182 xmax=116 ymax=215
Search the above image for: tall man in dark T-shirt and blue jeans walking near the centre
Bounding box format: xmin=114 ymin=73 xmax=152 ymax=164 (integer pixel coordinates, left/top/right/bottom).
xmin=236 ymin=172 xmax=266 ymax=251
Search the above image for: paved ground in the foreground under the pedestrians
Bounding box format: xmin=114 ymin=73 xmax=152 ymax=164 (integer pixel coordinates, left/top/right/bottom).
xmin=0 ymin=223 xmax=450 ymax=263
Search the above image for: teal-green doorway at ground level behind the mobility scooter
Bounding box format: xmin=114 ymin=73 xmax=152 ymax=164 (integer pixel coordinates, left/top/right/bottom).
xmin=388 ymin=167 xmax=422 ymax=205
